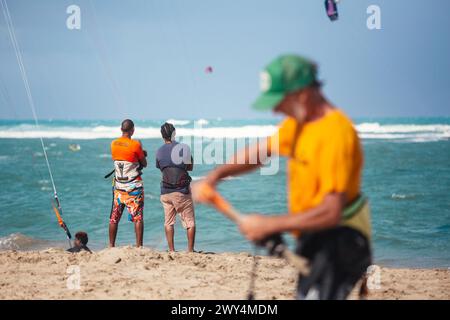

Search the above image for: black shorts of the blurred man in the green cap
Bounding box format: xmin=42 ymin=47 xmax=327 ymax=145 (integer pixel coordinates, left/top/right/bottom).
xmin=297 ymin=227 xmax=372 ymax=300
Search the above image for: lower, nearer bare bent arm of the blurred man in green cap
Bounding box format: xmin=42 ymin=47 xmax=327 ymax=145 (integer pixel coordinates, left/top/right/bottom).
xmin=239 ymin=193 xmax=346 ymax=241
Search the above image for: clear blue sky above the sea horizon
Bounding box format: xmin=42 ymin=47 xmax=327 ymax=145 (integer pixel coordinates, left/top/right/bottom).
xmin=0 ymin=0 xmax=450 ymax=119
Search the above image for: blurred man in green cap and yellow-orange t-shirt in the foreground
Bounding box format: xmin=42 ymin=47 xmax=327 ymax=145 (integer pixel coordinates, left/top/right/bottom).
xmin=194 ymin=55 xmax=371 ymax=299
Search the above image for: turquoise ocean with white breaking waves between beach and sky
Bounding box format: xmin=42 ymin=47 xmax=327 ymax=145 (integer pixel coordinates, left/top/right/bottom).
xmin=0 ymin=118 xmax=450 ymax=267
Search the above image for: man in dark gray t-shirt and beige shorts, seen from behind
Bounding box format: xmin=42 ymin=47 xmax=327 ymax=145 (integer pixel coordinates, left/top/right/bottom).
xmin=156 ymin=122 xmax=195 ymax=252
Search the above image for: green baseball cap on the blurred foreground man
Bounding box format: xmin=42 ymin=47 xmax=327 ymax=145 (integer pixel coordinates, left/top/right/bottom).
xmin=253 ymin=55 xmax=317 ymax=111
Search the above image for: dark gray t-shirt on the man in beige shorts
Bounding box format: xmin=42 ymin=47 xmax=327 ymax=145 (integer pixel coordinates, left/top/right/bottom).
xmin=156 ymin=141 xmax=192 ymax=194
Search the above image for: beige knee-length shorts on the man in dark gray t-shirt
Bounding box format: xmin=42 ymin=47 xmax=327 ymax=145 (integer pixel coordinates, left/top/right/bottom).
xmin=160 ymin=192 xmax=195 ymax=229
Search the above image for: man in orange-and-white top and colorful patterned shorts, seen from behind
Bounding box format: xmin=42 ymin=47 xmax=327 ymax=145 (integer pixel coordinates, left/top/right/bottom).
xmin=109 ymin=119 xmax=147 ymax=247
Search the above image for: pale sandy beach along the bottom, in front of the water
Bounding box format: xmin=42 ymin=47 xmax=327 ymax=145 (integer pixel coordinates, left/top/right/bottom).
xmin=0 ymin=247 xmax=450 ymax=300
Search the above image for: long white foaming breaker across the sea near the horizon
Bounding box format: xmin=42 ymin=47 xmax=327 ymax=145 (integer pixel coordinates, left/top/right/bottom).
xmin=0 ymin=119 xmax=450 ymax=142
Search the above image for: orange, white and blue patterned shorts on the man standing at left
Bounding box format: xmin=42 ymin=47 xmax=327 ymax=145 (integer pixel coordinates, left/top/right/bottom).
xmin=109 ymin=188 xmax=144 ymax=224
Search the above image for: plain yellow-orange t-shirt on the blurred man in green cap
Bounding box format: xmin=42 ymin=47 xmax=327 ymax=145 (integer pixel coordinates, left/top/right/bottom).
xmin=269 ymin=109 xmax=370 ymax=236
